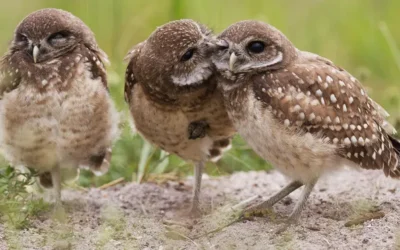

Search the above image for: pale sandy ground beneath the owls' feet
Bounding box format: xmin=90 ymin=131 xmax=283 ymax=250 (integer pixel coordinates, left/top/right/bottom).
xmin=0 ymin=170 xmax=400 ymax=250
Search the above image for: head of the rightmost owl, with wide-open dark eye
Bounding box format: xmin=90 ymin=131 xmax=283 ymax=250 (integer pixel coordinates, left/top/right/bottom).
xmin=213 ymin=20 xmax=296 ymax=75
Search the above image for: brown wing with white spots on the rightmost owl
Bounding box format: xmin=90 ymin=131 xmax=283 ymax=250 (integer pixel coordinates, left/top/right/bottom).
xmin=252 ymin=57 xmax=400 ymax=177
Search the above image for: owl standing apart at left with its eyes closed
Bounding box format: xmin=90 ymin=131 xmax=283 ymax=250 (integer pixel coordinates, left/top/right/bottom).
xmin=0 ymin=9 xmax=118 ymax=203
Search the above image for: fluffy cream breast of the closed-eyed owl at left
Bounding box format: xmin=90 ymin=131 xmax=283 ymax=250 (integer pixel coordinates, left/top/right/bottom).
xmin=0 ymin=65 xmax=119 ymax=170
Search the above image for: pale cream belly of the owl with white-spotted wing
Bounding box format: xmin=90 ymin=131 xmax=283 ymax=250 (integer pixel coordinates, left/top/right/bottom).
xmin=227 ymin=88 xmax=340 ymax=183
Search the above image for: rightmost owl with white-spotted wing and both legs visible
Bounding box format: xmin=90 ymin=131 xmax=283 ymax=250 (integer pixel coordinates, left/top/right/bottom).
xmin=213 ymin=21 xmax=400 ymax=225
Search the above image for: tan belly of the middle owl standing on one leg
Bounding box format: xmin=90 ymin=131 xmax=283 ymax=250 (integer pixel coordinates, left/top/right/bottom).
xmin=130 ymin=85 xmax=217 ymax=162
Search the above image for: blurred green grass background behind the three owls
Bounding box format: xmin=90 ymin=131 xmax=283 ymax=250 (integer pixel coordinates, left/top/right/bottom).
xmin=0 ymin=0 xmax=400 ymax=186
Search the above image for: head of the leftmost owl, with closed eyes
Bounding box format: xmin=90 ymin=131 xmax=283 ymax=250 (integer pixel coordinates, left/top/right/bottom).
xmin=11 ymin=9 xmax=97 ymax=64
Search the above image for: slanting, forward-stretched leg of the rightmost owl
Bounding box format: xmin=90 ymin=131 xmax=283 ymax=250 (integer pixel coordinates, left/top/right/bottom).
xmin=242 ymin=181 xmax=303 ymax=218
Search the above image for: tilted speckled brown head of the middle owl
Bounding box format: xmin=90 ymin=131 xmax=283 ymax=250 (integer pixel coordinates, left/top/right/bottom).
xmin=128 ymin=19 xmax=227 ymax=89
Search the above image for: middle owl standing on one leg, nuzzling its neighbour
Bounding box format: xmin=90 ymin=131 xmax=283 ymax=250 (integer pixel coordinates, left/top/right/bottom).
xmin=125 ymin=20 xmax=234 ymax=213
